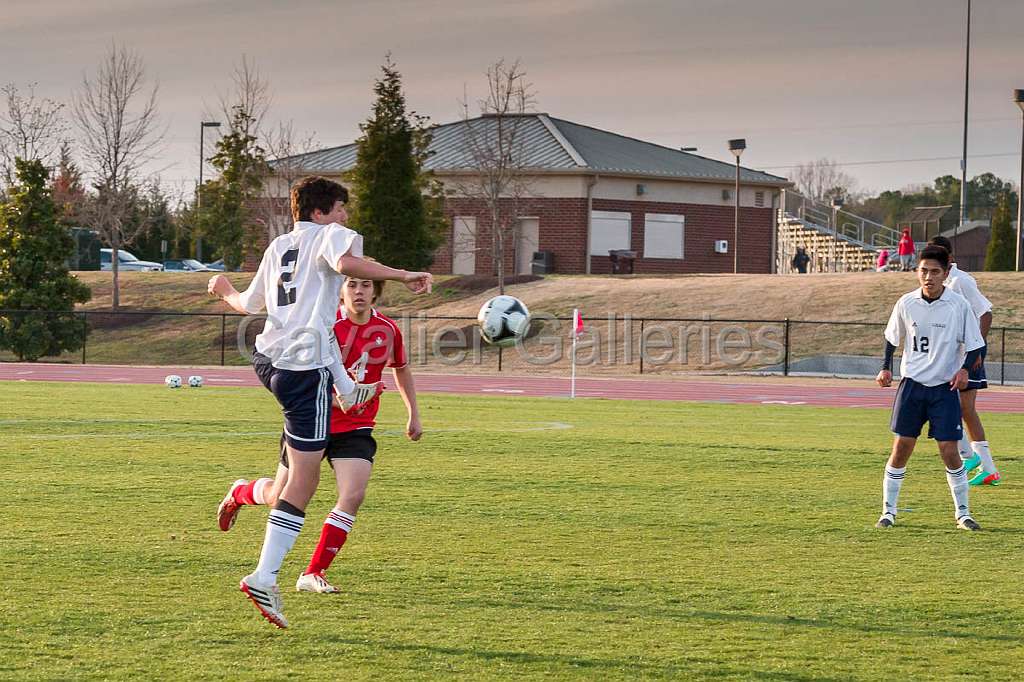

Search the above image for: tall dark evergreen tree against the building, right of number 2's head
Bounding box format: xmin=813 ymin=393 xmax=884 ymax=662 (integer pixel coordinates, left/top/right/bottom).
xmin=346 ymin=54 xmax=445 ymax=270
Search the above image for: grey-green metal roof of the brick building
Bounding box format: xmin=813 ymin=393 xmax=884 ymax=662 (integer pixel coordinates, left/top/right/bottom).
xmin=271 ymin=114 xmax=791 ymax=186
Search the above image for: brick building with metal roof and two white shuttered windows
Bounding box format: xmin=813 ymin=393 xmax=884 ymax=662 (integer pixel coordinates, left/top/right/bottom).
xmin=266 ymin=114 xmax=792 ymax=274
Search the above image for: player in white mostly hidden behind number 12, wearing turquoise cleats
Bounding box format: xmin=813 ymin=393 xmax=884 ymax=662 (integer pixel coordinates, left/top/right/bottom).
xmin=929 ymin=235 xmax=1002 ymax=485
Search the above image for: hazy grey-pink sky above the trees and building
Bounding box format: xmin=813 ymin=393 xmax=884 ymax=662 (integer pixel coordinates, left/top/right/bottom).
xmin=0 ymin=0 xmax=1024 ymax=197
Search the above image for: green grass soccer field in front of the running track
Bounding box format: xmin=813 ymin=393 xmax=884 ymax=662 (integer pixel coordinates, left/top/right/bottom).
xmin=0 ymin=382 xmax=1024 ymax=680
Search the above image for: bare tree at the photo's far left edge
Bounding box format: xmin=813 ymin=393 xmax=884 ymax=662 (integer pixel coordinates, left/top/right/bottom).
xmin=0 ymin=83 xmax=68 ymax=187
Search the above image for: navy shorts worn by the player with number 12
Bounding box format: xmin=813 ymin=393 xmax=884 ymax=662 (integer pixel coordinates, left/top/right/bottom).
xmin=890 ymin=379 xmax=964 ymax=440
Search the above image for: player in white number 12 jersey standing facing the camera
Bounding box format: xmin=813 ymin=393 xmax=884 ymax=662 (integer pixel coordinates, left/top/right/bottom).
xmin=874 ymin=246 xmax=985 ymax=530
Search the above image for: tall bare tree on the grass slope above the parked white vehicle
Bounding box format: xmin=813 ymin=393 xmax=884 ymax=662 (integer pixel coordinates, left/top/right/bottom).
xmin=73 ymin=44 xmax=163 ymax=308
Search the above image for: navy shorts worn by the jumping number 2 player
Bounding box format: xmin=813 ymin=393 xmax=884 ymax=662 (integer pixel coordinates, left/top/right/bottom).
xmin=253 ymin=353 xmax=333 ymax=453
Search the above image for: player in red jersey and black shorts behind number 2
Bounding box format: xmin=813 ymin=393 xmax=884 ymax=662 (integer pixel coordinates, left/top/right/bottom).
xmin=217 ymin=270 xmax=423 ymax=593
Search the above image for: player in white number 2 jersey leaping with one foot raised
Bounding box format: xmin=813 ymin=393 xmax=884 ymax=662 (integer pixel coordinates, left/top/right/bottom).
xmin=209 ymin=177 xmax=432 ymax=628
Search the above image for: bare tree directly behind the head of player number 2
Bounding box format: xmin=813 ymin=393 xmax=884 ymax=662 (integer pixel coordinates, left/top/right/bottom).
xmin=253 ymin=121 xmax=322 ymax=242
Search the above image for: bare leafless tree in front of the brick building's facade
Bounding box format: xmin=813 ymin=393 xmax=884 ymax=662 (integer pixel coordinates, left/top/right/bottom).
xmin=453 ymin=59 xmax=535 ymax=294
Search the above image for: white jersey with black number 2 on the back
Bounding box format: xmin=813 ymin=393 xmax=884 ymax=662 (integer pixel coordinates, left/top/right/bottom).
xmin=241 ymin=221 xmax=362 ymax=372
